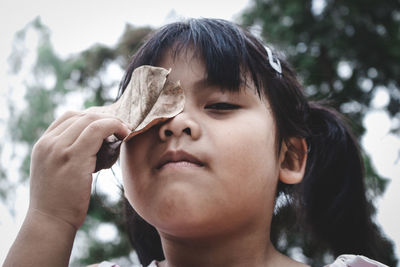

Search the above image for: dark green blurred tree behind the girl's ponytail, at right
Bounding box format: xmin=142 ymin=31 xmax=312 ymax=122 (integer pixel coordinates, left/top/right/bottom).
xmin=241 ymin=0 xmax=400 ymax=266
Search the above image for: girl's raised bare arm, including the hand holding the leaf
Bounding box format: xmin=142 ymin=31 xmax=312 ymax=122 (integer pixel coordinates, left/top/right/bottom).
xmin=4 ymin=112 xmax=130 ymax=267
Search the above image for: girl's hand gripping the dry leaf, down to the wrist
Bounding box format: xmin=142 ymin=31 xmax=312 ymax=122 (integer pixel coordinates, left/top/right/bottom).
xmin=29 ymin=112 xmax=131 ymax=229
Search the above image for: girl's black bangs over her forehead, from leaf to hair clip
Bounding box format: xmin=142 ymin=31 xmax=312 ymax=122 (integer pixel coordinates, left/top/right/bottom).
xmin=120 ymin=19 xmax=267 ymax=98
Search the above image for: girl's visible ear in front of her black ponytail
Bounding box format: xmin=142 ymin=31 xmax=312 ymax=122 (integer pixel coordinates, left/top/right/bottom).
xmin=279 ymin=137 xmax=307 ymax=184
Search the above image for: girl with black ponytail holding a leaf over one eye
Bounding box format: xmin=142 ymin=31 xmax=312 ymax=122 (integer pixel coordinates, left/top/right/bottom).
xmin=5 ymin=19 xmax=390 ymax=266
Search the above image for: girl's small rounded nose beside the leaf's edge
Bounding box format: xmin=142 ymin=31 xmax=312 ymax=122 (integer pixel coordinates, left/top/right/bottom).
xmin=159 ymin=112 xmax=201 ymax=141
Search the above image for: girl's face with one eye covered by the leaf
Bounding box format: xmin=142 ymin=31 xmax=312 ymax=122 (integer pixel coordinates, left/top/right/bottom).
xmin=121 ymin=49 xmax=280 ymax=238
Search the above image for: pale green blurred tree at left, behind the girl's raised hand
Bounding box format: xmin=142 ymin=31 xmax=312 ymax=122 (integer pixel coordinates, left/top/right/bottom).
xmin=6 ymin=18 xmax=151 ymax=266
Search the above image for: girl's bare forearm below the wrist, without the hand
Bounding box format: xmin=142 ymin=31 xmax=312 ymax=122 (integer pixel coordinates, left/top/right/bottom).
xmin=3 ymin=211 xmax=76 ymax=267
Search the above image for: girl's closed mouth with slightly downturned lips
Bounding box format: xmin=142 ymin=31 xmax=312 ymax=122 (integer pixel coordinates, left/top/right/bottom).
xmin=156 ymin=150 xmax=204 ymax=170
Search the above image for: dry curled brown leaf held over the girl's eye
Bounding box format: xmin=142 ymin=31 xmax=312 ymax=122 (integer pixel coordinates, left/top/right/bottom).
xmin=87 ymin=66 xmax=185 ymax=172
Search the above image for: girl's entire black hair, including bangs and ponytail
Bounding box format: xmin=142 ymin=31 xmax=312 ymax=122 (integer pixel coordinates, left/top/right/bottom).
xmin=119 ymin=19 xmax=390 ymax=265
